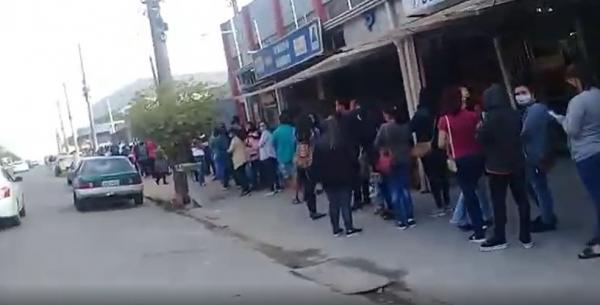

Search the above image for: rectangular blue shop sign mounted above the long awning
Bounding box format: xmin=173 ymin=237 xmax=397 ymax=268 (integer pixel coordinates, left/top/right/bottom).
xmin=253 ymin=20 xmax=323 ymax=80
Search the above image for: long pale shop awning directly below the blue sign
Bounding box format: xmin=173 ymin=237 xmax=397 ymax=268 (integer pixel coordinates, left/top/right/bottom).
xmin=237 ymin=39 xmax=393 ymax=98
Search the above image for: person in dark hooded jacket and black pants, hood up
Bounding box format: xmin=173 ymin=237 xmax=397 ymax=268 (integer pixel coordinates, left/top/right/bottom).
xmin=477 ymin=84 xmax=533 ymax=251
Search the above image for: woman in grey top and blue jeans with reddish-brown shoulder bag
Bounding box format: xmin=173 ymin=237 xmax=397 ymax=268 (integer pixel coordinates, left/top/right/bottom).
xmin=375 ymin=106 xmax=417 ymax=230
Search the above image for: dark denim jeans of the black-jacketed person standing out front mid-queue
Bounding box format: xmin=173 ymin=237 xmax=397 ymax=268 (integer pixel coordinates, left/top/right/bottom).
xmin=325 ymin=186 xmax=354 ymax=234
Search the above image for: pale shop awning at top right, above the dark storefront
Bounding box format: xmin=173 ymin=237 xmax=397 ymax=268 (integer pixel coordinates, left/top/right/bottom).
xmin=391 ymin=0 xmax=516 ymax=38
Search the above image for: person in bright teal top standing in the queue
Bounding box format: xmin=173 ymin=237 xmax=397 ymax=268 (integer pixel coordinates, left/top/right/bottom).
xmin=273 ymin=112 xmax=296 ymax=192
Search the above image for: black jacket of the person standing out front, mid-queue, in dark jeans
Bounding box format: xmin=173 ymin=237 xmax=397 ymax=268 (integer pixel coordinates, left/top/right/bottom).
xmin=312 ymin=127 xmax=358 ymax=188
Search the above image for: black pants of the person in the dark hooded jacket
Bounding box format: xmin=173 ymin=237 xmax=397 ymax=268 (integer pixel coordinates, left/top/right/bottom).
xmin=489 ymin=170 xmax=531 ymax=242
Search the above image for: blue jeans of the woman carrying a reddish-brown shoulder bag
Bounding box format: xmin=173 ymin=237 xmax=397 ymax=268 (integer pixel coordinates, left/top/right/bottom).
xmin=387 ymin=166 xmax=414 ymax=224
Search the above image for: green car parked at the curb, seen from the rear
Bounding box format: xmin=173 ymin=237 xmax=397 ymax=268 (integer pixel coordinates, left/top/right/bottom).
xmin=72 ymin=156 xmax=144 ymax=211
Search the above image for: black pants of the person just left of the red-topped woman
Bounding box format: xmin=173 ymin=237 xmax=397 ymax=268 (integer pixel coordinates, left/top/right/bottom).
xmin=421 ymin=149 xmax=450 ymax=209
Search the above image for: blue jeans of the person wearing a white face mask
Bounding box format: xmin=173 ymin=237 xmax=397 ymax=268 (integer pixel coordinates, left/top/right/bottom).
xmin=527 ymin=165 xmax=556 ymax=224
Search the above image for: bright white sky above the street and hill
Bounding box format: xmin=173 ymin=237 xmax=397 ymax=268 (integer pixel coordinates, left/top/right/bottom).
xmin=0 ymin=0 xmax=249 ymax=159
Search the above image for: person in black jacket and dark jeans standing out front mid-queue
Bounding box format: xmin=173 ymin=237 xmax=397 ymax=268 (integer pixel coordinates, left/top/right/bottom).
xmin=312 ymin=117 xmax=363 ymax=237
